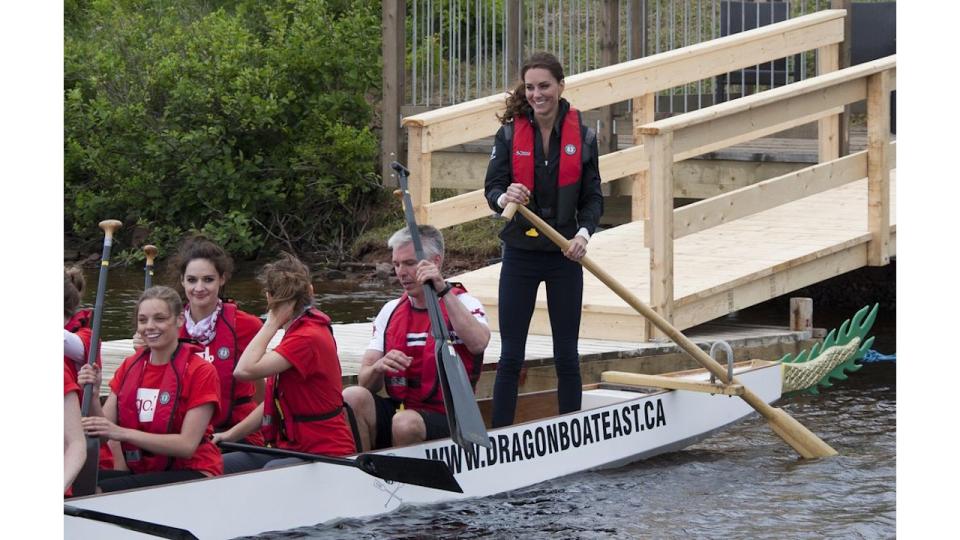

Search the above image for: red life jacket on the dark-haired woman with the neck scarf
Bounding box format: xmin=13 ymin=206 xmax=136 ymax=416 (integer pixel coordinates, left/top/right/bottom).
xmin=180 ymin=300 xmax=256 ymax=430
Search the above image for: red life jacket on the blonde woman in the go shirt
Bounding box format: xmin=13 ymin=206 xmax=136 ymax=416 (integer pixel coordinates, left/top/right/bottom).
xmin=117 ymin=343 xmax=203 ymax=473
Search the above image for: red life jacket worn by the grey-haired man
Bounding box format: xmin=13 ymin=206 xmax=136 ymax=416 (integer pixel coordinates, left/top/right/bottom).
xmin=383 ymin=283 xmax=483 ymax=413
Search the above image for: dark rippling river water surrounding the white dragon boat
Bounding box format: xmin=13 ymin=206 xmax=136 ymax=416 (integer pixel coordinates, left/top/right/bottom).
xmin=79 ymin=269 xmax=896 ymax=539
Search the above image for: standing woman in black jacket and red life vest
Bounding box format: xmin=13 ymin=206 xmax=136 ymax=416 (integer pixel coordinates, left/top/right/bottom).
xmin=484 ymin=52 xmax=603 ymax=427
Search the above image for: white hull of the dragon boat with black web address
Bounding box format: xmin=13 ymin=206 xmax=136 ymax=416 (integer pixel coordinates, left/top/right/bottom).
xmin=64 ymin=363 xmax=781 ymax=539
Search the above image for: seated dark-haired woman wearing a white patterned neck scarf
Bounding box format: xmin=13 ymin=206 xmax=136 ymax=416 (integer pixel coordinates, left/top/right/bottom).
xmin=170 ymin=236 xmax=264 ymax=446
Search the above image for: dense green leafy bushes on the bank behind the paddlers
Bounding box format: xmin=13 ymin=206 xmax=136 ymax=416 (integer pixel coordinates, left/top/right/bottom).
xmin=64 ymin=0 xmax=381 ymax=257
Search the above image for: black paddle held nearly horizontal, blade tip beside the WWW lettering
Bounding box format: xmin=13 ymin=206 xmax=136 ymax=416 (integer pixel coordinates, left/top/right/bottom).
xmin=219 ymin=441 xmax=463 ymax=493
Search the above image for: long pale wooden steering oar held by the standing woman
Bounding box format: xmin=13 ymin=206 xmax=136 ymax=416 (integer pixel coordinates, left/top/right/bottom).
xmin=504 ymin=203 xmax=837 ymax=459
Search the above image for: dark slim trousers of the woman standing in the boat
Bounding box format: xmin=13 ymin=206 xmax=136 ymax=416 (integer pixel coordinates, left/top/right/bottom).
xmin=492 ymin=247 xmax=583 ymax=427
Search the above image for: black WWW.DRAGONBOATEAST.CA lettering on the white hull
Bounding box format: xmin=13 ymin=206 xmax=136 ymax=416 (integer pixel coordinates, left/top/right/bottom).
xmin=426 ymin=398 xmax=667 ymax=474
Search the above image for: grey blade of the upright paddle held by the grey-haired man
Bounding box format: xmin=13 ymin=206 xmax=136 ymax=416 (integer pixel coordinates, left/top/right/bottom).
xmin=436 ymin=342 xmax=492 ymax=452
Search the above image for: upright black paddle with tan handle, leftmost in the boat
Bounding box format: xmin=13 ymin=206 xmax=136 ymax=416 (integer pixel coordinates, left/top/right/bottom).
xmin=73 ymin=219 xmax=123 ymax=496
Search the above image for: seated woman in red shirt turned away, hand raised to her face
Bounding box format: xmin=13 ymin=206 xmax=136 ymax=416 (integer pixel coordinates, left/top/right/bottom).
xmin=215 ymin=253 xmax=356 ymax=473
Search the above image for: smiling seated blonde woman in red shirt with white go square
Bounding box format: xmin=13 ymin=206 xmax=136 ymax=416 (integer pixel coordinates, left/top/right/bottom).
xmin=79 ymin=286 xmax=223 ymax=491
